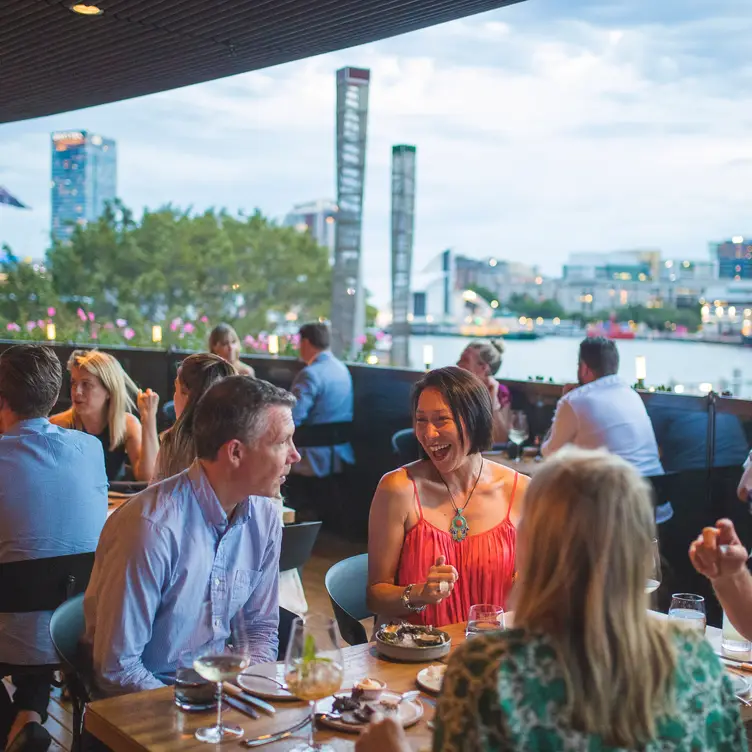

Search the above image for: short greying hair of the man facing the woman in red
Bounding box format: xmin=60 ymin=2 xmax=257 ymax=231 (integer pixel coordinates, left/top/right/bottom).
xmin=193 ymin=376 xmax=295 ymax=460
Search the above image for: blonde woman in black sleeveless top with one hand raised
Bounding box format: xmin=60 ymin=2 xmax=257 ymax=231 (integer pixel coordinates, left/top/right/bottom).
xmin=50 ymin=350 xmax=159 ymax=481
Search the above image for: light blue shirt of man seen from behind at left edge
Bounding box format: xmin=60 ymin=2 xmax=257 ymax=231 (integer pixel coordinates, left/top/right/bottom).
xmin=0 ymin=418 xmax=107 ymax=666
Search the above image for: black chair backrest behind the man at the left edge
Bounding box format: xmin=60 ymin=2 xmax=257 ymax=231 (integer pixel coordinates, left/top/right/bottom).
xmin=0 ymin=551 xmax=94 ymax=614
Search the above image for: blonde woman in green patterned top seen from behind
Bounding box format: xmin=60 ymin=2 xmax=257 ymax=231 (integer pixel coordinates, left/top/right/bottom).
xmin=357 ymin=449 xmax=747 ymax=752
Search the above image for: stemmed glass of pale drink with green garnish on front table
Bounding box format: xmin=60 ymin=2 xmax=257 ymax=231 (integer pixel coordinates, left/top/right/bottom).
xmin=285 ymin=614 xmax=344 ymax=752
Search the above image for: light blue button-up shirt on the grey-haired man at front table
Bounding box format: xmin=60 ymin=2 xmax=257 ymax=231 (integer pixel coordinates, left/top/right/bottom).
xmin=84 ymin=460 xmax=282 ymax=695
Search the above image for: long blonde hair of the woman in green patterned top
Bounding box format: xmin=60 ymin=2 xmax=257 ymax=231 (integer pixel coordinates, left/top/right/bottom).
xmin=514 ymin=449 xmax=676 ymax=749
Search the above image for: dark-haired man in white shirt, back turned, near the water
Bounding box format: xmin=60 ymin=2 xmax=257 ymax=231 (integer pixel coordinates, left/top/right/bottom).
xmin=541 ymin=337 xmax=663 ymax=477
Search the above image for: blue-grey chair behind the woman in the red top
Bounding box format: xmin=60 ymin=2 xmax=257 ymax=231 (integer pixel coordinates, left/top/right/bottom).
xmin=325 ymin=554 xmax=374 ymax=645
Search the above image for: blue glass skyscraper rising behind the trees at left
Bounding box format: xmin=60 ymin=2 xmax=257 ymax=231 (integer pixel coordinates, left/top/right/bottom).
xmin=51 ymin=131 xmax=117 ymax=240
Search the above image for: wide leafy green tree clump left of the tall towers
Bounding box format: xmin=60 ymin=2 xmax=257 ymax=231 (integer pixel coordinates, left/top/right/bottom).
xmin=47 ymin=201 xmax=331 ymax=331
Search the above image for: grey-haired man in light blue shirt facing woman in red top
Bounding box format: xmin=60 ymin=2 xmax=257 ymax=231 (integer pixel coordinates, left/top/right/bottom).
xmin=84 ymin=376 xmax=300 ymax=695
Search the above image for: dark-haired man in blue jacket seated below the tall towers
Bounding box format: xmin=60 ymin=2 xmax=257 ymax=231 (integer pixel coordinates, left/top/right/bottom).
xmin=291 ymin=323 xmax=355 ymax=478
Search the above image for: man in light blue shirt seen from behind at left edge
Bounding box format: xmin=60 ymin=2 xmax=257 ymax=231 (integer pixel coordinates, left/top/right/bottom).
xmin=0 ymin=345 xmax=107 ymax=750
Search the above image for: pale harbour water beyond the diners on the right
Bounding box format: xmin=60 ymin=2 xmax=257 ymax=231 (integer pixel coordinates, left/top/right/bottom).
xmin=410 ymin=336 xmax=752 ymax=399
